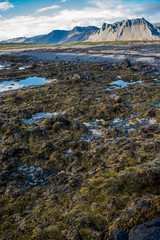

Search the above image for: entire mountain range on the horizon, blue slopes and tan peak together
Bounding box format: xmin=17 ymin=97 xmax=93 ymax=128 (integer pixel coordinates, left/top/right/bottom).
xmin=2 ymin=18 xmax=160 ymax=43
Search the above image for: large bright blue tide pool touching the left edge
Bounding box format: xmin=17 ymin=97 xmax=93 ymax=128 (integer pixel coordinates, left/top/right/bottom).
xmin=0 ymin=77 xmax=55 ymax=92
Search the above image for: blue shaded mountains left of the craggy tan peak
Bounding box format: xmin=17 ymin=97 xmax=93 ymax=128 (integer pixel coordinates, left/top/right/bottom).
xmin=5 ymin=26 xmax=99 ymax=43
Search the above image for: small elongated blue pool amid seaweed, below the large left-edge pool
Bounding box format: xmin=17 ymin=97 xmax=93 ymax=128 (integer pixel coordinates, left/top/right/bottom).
xmin=24 ymin=111 xmax=62 ymax=125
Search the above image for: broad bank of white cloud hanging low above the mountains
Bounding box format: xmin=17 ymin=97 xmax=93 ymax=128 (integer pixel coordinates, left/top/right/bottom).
xmin=0 ymin=0 xmax=160 ymax=40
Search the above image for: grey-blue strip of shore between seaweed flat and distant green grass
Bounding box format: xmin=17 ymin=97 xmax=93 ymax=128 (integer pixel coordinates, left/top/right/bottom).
xmin=0 ymin=44 xmax=160 ymax=68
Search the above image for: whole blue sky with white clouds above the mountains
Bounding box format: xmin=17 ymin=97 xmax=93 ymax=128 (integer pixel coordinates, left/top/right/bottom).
xmin=0 ymin=0 xmax=160 ymax=41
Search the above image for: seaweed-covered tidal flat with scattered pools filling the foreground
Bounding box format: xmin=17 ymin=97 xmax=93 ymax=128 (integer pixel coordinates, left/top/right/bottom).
xmin=0 ymin=45 xmax=160 ymax=240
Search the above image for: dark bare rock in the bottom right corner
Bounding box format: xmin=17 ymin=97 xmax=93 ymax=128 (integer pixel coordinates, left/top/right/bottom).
xmin=129 ymin=217 xmax=160 ymax=240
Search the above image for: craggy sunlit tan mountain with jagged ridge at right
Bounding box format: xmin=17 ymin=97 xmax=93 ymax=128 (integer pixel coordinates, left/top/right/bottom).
xmin=89 ymin=18 xmax=160 ymax=41
